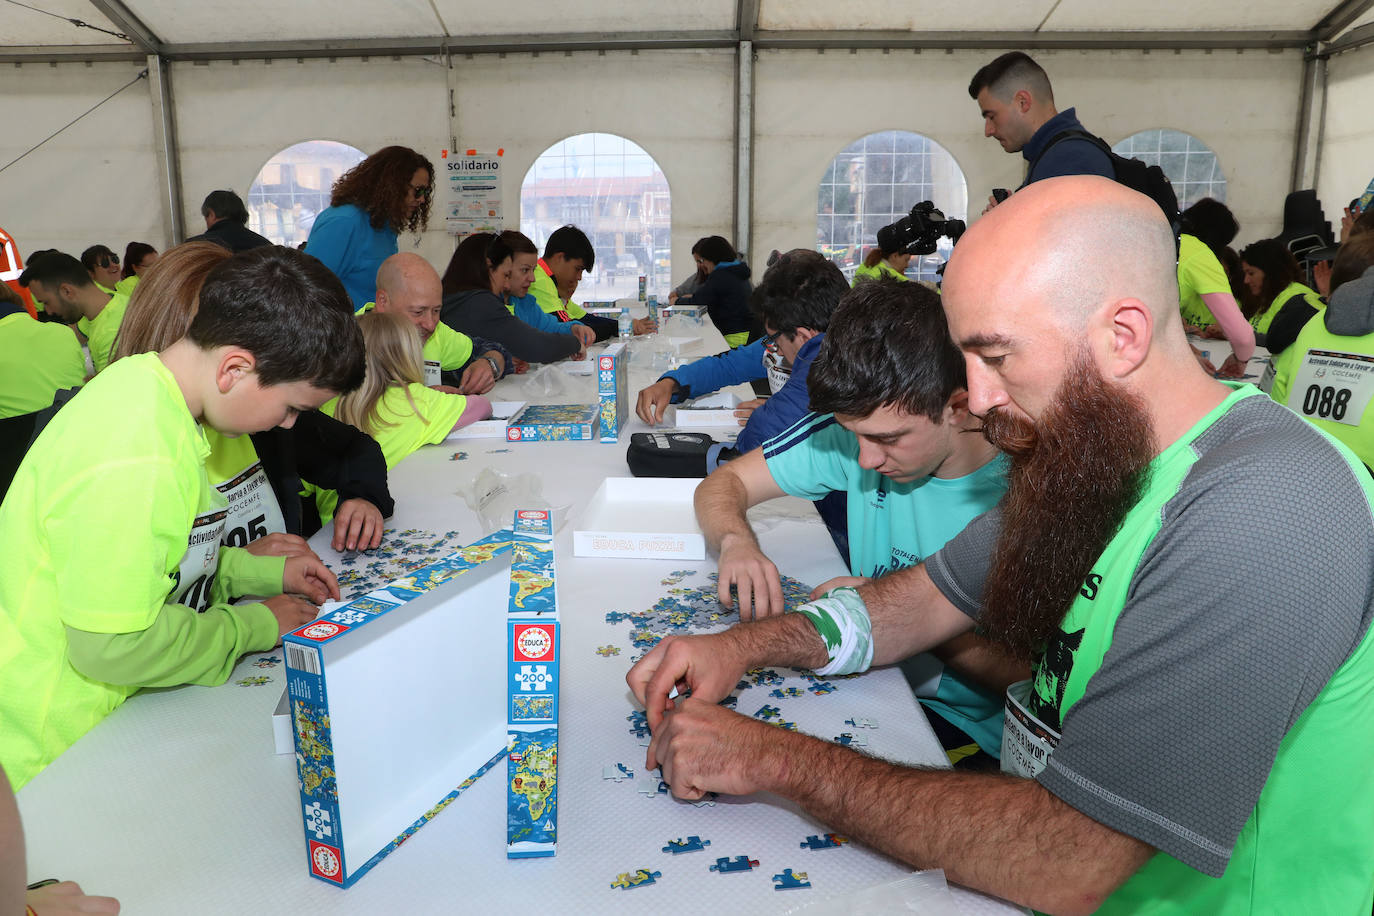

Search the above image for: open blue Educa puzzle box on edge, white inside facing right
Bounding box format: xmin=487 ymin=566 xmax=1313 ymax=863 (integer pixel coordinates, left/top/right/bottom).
xmin=282 ymin=530 xmax=513 ymax=887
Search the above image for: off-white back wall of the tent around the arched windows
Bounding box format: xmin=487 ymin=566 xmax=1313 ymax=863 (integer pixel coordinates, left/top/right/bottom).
xmin=0 ymin=49 xmax=1308 ymax=275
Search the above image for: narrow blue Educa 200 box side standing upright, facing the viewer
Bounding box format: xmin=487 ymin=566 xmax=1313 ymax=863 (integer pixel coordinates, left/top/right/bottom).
xmin=506 ymin=509 xmax=561 ymax=858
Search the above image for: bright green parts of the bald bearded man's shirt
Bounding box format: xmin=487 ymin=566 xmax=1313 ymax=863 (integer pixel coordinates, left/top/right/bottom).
xmin=1004 ymin=386 xmax=1374 ymax=916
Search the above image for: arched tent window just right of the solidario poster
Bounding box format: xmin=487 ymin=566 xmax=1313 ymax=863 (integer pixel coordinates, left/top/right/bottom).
xmin=519 ymin=133 xmax=673 ymax=304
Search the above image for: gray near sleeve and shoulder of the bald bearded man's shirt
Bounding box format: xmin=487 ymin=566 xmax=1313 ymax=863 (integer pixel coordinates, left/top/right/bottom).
xmin=1039 ymin=420 xmax=1374 ymax=876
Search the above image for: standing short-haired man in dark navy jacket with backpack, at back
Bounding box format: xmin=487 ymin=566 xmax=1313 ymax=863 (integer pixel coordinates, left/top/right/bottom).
xmin=969 ymin=51 xmax=1116 ymax=213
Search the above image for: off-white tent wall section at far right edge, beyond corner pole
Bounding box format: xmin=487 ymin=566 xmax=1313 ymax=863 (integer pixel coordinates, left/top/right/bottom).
xmin=1318 ymin=45 xmax=1374 ymax=229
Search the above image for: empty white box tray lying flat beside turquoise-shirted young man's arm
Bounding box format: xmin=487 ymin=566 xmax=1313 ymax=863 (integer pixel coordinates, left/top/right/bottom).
xmin=573 ymin=477 xmax=706 ymax=560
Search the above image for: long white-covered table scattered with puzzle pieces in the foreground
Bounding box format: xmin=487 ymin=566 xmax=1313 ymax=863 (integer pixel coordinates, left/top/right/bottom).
xmin=19 ymin=336 xmax=1022 ymax=916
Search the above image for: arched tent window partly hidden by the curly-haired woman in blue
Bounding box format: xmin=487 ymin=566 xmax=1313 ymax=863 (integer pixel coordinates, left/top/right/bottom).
xmin=245 ymin=140 xmax=367 ymax=249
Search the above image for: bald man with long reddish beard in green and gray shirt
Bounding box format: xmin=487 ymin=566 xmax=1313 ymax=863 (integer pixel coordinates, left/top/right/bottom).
xmin=627 ymin=176 xmax=1374 ymax=913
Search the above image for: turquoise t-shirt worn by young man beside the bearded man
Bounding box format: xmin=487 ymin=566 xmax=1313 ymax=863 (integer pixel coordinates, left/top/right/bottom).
xmin=764 ymin=413 xmax=1007 ymax=758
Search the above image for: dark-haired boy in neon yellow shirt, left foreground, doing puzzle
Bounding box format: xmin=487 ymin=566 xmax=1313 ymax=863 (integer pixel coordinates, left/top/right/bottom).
xmin=0 ymin=247 xmax=363 ymax=788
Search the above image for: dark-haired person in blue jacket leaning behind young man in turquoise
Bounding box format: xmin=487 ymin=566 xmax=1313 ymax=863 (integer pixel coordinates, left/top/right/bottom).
xmin=635 ymin=249 xmax=849 ymax=452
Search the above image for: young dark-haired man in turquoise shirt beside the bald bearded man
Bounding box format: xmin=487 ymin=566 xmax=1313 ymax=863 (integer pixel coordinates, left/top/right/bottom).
xmin=697 ymin=280 xmax=1028 ymax=766
